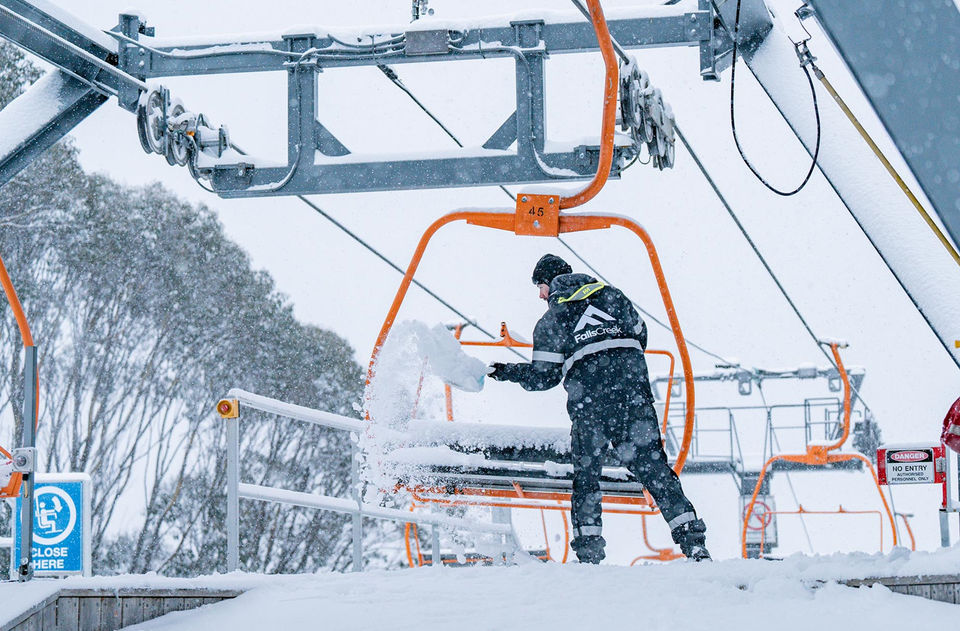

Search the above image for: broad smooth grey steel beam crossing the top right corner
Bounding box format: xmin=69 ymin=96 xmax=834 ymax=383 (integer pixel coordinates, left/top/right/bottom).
xmin=810 ymin=0 xmax=960 ymax=251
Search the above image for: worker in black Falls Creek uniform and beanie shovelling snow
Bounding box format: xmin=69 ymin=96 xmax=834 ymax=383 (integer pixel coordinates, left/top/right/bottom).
xmin=489 ymin=254 xmax=710 ymax=563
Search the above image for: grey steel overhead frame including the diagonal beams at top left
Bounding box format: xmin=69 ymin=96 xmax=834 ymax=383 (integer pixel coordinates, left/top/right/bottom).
xmin=0 ymin=0 xmax=729 ymax=197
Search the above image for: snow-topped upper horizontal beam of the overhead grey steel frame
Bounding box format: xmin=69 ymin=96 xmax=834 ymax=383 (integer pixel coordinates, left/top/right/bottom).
xmin=125 ymin=7 xmax=714 ymax=78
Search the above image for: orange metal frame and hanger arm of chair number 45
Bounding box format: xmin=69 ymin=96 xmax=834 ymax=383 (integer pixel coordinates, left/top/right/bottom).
xmin=367 ymin=0 xmax=695 ymax=556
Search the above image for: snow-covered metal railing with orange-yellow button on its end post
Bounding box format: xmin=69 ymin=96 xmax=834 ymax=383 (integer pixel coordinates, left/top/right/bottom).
xmin=217 ymin=388 xmax=512 ymax=572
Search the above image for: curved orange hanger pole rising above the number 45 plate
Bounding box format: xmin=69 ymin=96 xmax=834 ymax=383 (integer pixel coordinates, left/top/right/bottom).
xmin=560 ymin=0 xmax=620 ymax=210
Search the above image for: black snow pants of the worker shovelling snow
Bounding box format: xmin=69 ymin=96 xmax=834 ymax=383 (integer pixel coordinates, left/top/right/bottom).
xmin=567 ymin=362 xmax=696 ymax=558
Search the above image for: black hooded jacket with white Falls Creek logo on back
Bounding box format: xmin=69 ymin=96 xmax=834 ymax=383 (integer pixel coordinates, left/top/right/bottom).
xmin=504 ymin=274 xmax=652 ymax=400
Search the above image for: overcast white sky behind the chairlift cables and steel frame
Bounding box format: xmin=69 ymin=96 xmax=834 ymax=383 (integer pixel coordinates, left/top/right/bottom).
xmin=9 ymin=0 xmax=960 ymax=552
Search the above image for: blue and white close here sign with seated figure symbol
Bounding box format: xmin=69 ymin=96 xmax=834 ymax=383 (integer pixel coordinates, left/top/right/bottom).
xmin=13 ymin=474 xmax=90 ymax=576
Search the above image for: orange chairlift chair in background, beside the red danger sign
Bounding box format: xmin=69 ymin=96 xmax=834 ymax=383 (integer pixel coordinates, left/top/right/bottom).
xmin=740 ymin=342 xmax=897 ymax=558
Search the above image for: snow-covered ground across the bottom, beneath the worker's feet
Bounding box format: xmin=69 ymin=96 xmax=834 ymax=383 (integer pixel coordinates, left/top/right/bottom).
xmin=0 ymin=547 xmax=960 ymax=631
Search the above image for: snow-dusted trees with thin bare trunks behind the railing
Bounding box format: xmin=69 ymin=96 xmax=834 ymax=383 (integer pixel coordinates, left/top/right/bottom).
xmin=0 ymin=46 xmax=377 ymax=575
